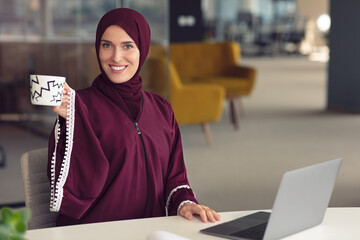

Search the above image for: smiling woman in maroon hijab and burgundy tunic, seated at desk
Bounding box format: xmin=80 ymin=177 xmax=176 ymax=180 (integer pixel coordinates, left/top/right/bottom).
xmin=48 ymin=8 xmax=220 ymax=226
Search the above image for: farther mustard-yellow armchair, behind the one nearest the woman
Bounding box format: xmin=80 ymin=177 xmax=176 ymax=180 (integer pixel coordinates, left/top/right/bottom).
xmin=170 ymin=42 xmax=256 ymax=129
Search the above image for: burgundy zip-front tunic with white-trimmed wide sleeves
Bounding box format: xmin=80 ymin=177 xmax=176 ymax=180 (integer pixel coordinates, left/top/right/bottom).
xmin=48 ymin=10 xmax=198 ymax=225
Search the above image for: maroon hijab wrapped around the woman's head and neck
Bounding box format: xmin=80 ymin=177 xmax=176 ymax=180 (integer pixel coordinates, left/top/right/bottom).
xmin=93 ymin=8 xmax=150 ymax=121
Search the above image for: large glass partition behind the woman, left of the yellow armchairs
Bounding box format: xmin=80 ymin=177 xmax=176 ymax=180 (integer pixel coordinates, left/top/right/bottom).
xmin=0 ymin=0 xmax=167 ymax=205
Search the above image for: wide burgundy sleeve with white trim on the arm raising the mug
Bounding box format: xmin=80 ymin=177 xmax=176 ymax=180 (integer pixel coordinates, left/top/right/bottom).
xmin=49 ymin=91 xmax=109 ymax=219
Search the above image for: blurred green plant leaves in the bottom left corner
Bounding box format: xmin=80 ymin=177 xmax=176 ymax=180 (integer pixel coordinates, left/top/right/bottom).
xmin=0 ymin=207 xmax=31 ymax=240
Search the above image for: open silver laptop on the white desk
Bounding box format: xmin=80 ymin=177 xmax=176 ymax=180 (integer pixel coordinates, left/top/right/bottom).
xmin=200 ymin=158 xmax=342 ymax=240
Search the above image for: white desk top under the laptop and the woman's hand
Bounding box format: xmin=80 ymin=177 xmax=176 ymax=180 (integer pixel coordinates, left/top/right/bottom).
xmin=26 ymin=208 xmax=360 ymax=240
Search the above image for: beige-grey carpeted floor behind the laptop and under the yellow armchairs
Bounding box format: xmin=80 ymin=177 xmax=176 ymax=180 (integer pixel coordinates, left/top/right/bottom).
xmin=181 ymin=57 xmax=360 ymax=211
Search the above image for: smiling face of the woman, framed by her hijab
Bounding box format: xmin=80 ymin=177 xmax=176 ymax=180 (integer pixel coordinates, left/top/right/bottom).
xmin=99 ymin=25 xmax=140 ymax=83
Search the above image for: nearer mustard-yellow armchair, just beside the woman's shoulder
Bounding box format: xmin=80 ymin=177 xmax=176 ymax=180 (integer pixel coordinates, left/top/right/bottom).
xmin=143 ymin=56 xmax=225 ymax=146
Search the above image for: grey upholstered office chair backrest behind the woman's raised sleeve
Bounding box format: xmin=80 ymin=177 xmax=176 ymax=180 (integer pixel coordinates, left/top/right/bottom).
xmin=21 ymin=148 xmax=58 ymax=229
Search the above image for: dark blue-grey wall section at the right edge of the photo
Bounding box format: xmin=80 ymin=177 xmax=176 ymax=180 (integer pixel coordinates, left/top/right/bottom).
xmin=328 ymin=0 xmax=360 ymax=112
